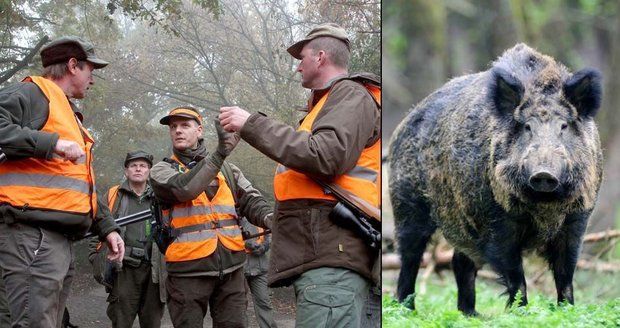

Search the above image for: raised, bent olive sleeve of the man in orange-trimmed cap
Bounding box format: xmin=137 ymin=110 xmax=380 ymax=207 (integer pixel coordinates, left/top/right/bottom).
xmin=150 ymin=152 xmax=224 ymax=204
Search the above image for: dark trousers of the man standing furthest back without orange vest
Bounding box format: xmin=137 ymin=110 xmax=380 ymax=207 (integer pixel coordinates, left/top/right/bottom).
xmin=107 ymin=261 xmax=165 ymax=328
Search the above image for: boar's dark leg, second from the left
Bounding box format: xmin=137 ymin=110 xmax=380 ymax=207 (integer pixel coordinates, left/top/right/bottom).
xmin=452 ymin=251 xmax=478 ymax=316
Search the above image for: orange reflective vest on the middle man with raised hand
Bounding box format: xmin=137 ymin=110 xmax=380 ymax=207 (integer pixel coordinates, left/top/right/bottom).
xmin=162 ymin=156 xmax=245 ymax=262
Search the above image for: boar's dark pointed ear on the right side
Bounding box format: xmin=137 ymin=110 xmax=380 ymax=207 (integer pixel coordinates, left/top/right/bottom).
xmin=564 ymin=68 xmax=603 ymax=118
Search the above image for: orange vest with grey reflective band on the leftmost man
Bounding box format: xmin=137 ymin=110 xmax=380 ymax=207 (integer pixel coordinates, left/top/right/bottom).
xmin=0 ymin=76 xmax=97 ymax=218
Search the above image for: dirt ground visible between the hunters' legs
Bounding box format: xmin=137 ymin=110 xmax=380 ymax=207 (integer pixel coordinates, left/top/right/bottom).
xmin=67 ymin=271 xmax=295 ymax=328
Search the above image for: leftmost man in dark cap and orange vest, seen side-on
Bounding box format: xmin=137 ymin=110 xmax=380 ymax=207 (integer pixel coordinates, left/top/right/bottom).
xmin=0 ymin=37 xmax=124 ymax=327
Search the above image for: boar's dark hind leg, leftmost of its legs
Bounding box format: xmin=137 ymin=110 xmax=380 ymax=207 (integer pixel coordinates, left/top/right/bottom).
xmin=394 ymin=197 xmax=437 ymax=309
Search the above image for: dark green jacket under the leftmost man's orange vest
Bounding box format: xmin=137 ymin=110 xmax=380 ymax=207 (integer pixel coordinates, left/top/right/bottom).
xmin=0 ymin=78 xmax=119 ymax=240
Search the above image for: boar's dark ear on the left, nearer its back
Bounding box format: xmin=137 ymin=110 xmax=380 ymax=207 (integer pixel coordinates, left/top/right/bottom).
xmin=489 ymin=67 xmax=524 ymax=114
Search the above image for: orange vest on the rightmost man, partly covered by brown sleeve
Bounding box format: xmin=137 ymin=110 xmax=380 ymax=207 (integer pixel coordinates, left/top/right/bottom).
xmin=273 ymin=84 xmax=381 ymax=207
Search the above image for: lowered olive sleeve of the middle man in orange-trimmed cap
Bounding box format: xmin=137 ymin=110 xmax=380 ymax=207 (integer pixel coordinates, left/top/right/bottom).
xmin=230 ymin=164 xmax=273 ymax=229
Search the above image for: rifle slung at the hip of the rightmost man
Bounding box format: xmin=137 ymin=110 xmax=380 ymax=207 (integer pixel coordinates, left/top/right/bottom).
xmin=312 ymin=178 xmax=381 ymax=250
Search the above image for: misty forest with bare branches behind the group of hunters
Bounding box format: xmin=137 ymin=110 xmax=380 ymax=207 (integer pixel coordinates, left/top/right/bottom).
xmin=0 ymin=0 xmax=381 ymax=217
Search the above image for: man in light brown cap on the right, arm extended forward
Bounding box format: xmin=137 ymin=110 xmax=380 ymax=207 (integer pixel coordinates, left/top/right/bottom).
xmin=219 ymin=23 xmax=381 ymax=327
